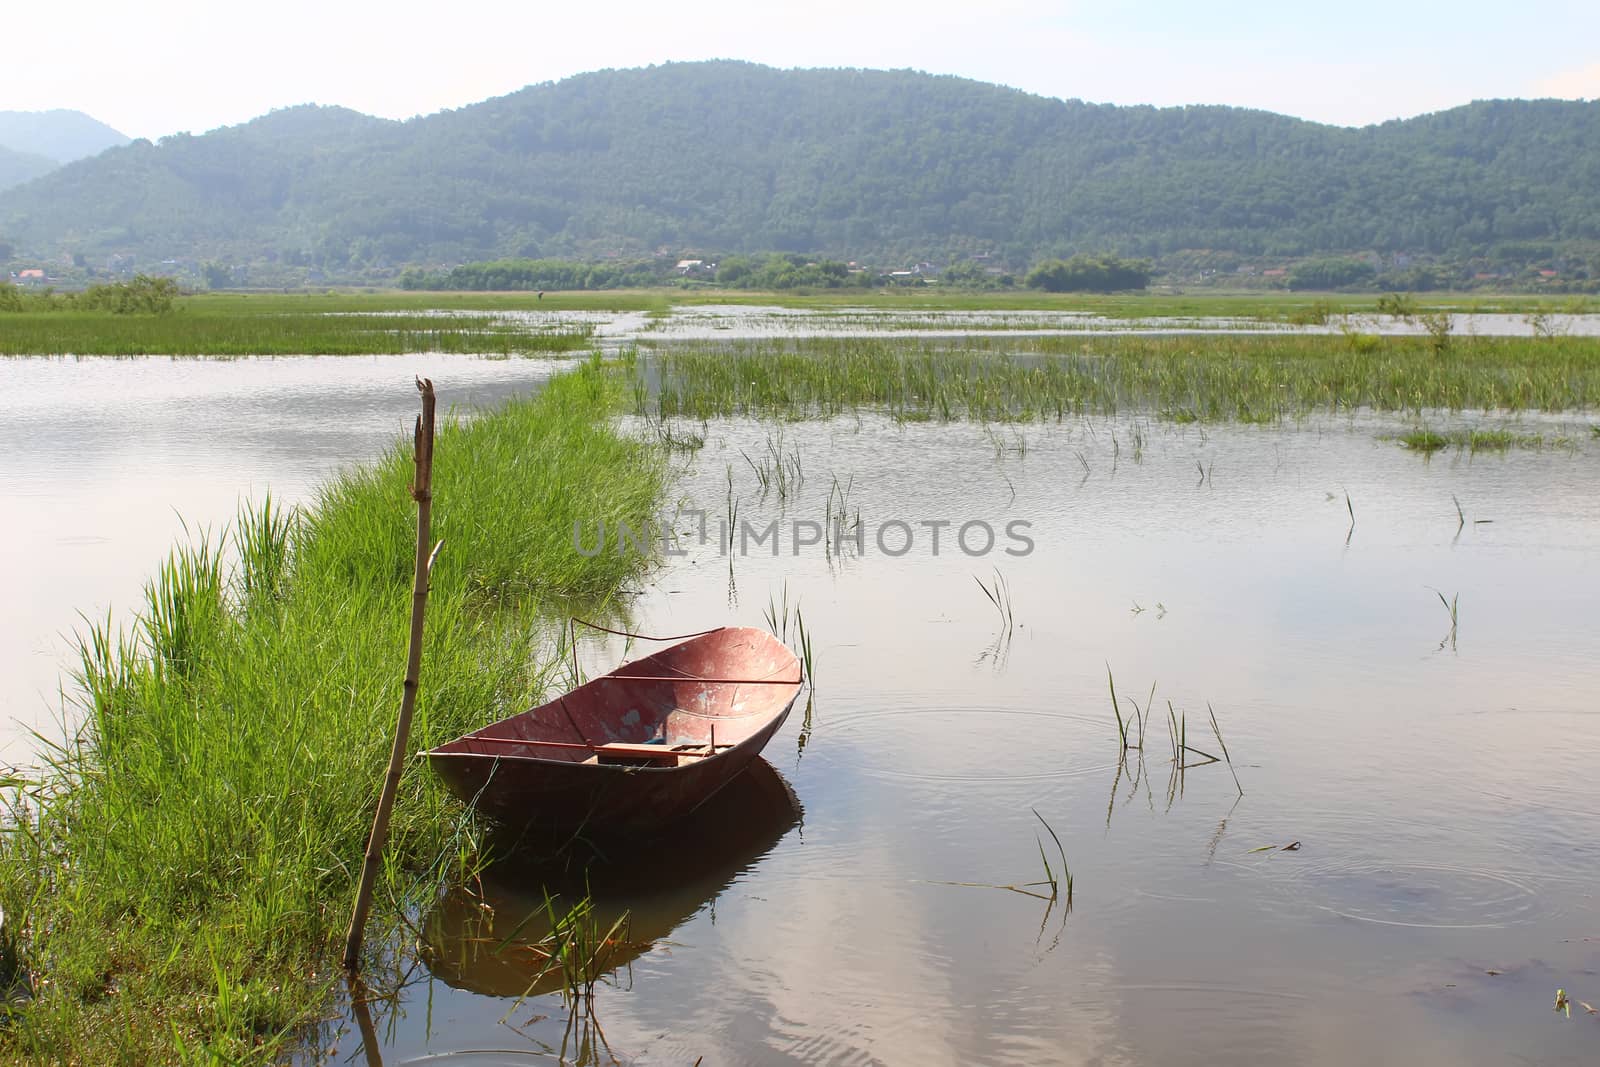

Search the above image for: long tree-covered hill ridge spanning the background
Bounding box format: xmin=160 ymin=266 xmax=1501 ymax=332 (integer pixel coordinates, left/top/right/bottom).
xmin=0 ymin=62 xmax=1600 ymax=269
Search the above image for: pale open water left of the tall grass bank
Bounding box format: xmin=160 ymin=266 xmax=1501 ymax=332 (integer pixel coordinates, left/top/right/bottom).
xmin=0 ymin=355 xmax=560 ymax=763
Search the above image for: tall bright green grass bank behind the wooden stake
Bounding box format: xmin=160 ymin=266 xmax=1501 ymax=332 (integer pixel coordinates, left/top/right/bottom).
xmin=0 ymin=362 xmax=667 ymax=1064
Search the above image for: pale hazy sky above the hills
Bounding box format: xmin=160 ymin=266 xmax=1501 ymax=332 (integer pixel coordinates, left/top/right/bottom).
xmin=12 ymin=0 xmax=1600 ymax=138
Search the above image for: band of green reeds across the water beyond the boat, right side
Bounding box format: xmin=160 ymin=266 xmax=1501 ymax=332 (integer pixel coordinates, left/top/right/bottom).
xmin=637 ymin=336 xmax=1600 ymax=422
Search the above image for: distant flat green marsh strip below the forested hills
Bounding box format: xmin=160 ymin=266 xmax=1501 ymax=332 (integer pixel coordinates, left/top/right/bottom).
xmin=0 ymin=286 xmax=1600 ymax=355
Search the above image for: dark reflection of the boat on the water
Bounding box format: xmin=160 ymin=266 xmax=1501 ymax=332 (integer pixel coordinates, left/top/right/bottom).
xmin=422 ymin=758 xmax=802 ymax=997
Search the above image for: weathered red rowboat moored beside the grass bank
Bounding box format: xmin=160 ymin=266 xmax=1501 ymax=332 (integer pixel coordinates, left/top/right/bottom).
xmin=426 ymin=627 xmax=802 ymax=835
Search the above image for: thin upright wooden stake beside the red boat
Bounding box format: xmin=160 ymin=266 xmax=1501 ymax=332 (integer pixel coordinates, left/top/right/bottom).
xmin=344 ymin=378 xmax=443 ymax=974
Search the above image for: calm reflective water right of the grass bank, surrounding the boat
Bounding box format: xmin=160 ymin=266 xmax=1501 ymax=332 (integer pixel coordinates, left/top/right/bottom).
xmin=322 ymin=418 xmax=1600 ymax=1064
